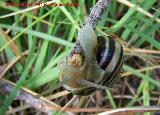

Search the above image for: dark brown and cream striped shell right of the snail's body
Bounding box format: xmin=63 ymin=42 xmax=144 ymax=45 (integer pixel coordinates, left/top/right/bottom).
xmin=96 ymin=35 xmax=123 ymax=87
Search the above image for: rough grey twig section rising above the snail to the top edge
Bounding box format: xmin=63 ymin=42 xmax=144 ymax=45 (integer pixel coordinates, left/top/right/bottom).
xmin=85 ymin=0 xmax=112 ymax=27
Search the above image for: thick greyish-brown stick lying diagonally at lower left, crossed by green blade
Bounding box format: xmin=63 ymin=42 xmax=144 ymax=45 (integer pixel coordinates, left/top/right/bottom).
xmin=0 ymin=79 xmax=61 ymax=113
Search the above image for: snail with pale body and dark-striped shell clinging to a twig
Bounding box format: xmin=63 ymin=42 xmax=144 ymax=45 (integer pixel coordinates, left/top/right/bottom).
xmin=59 ymin=24 xmax=123 ymax=95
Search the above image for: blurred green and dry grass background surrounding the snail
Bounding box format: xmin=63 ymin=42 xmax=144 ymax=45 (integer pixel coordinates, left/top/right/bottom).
xmin=0 ymin=0 xmax=160 ymax=115
